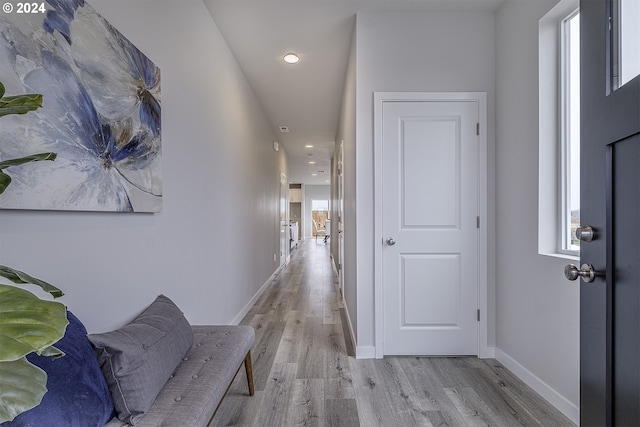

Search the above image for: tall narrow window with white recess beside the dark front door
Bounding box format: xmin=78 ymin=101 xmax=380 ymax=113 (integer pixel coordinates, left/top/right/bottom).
xmin=538 ymin=0 xmax=580 ymax=259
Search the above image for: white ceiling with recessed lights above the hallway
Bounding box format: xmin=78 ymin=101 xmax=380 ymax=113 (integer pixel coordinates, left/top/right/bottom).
xmin=204 ymin=0 xmax=502 ymax=185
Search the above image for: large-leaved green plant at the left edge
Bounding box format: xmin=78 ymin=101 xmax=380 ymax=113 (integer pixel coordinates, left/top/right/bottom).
xmin=0 ymin=82 xmax=68 ymax=423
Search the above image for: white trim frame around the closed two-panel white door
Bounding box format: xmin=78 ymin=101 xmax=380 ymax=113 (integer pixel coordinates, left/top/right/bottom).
xmin=373 ymin=92 xmax=494 ymax=359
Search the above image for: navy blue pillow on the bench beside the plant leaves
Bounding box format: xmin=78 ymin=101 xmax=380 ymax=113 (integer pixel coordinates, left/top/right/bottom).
xmin=2 ymin=311 xmax=113 ymax=427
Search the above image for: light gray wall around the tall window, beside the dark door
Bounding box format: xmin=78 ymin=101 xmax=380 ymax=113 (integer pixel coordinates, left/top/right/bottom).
xmin=496 ymin=0 xmax=580 ymax=421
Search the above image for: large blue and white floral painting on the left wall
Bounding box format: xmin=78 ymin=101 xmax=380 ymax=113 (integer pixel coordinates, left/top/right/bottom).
xmin=0 ymin=0 xmax=162 ymax=212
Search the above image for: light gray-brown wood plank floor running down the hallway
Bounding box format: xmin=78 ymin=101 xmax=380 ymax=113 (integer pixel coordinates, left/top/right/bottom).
xmin=211 ymin=240 xmax=574 ymax=427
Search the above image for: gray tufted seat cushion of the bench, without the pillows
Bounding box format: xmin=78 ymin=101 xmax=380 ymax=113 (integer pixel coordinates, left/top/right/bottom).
xmin=107 ymin=325 xmax=255 ymax=427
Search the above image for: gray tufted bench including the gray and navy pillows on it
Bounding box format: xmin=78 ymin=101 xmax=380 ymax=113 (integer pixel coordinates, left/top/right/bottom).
xmin=1 ymin=295 xmax=255 ymax=427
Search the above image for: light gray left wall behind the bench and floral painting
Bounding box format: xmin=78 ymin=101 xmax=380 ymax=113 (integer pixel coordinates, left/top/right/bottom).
xmin=0 ymin=0 xmax=286 ymax=331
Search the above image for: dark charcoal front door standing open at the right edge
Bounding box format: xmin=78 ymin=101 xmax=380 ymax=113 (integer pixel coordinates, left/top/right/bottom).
xmin=580 ymin=0 xmax=640 ymax=426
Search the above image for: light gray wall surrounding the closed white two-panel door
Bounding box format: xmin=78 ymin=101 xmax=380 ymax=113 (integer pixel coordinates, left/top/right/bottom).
xmin=352 ymin=12 xmax=495 ymax=356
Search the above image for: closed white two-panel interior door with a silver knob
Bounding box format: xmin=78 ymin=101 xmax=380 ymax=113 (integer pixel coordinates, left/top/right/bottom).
xmin=382 ymin=100 xmax=479 ymax=355
